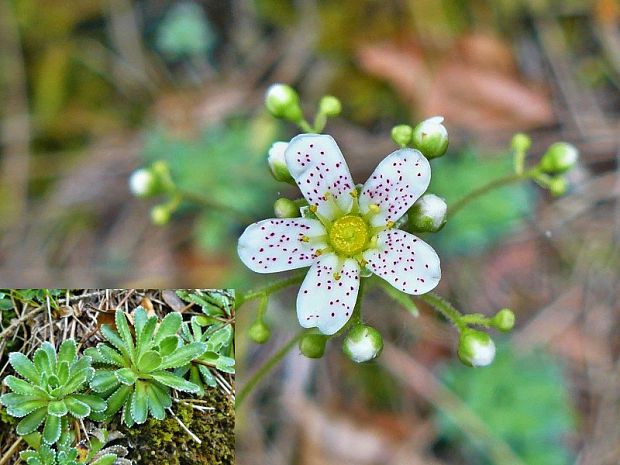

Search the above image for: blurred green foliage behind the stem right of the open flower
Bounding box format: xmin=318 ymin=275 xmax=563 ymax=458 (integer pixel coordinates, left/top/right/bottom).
xmin=428 ymin=149 xmax=534 ymax=256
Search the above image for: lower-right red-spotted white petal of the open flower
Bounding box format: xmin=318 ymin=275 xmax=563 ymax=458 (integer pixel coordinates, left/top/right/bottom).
xmin=363 ymin=229 xmax=441 ymax=294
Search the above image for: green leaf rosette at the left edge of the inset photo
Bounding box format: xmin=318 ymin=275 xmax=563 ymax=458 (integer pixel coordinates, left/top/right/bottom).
xmin=0 ymin=339 xmax=106 ymax=444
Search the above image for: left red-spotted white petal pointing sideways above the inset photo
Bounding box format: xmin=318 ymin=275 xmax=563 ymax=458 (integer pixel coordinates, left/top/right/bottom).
xmin=237 ymin=218 xmax=326 ymax=273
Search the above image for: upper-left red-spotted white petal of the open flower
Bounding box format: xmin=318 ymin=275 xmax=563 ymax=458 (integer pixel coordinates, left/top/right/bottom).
xmin=284 ymin=134 xmax=354 ymax=220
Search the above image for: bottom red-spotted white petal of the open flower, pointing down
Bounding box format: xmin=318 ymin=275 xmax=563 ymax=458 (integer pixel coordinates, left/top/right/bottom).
xmin=297 ymin=253 xmax=360 ymax=334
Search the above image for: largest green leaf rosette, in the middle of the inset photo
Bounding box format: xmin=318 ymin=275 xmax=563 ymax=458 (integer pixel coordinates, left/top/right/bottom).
xmin=85 ymin=307 xmax=207 ymax=427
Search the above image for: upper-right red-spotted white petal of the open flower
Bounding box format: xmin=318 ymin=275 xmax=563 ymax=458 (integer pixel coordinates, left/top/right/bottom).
xmin=359 ymin=149 xmax=431 ymax=226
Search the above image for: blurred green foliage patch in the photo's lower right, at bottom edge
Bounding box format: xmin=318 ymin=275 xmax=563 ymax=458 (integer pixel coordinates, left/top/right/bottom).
xmin=436 ymin=345 xmax=576 ymax=465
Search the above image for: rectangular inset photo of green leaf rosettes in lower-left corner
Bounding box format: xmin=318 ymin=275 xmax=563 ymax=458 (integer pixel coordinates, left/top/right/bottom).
xmin=0 ymin=289 xmax=235 ymax=465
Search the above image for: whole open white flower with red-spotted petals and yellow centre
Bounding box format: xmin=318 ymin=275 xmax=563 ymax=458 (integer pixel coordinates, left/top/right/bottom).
xmin=238 ymin=134 xmax=441 ymax=334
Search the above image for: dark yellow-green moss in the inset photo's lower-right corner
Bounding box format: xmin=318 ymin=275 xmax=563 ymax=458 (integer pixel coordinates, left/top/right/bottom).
xmin=123 ymin=389 xmax=235 ymax=465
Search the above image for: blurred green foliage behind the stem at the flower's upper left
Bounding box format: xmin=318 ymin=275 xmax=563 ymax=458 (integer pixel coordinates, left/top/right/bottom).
xmin=143 ymin=117 xmax=279 ymax=253
